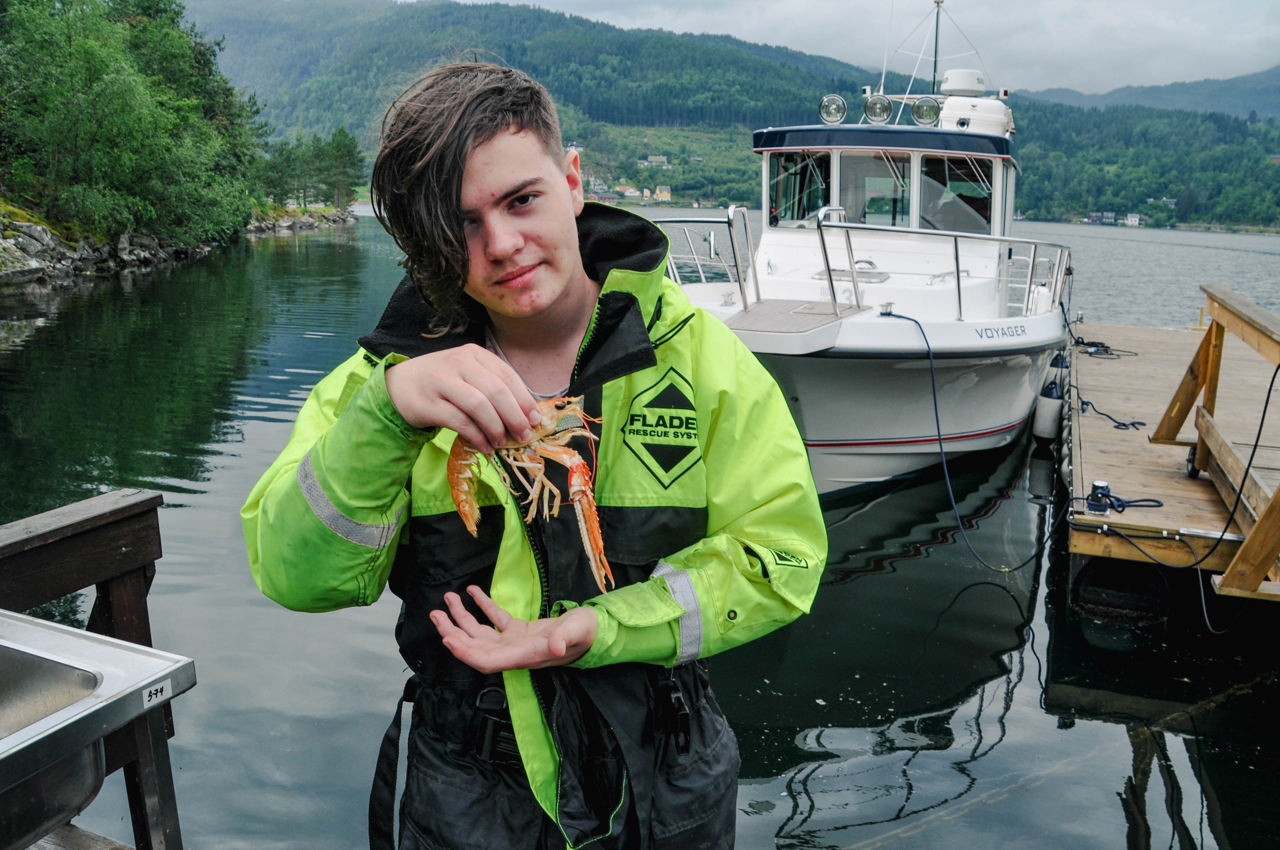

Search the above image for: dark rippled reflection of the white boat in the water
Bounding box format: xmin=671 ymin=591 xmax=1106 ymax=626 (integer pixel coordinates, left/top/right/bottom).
xmin=716 ymin=443 xmax=1050 ymax=847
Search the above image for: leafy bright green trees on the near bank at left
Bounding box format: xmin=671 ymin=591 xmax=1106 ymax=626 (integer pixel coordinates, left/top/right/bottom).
xmin=0 ymin=0 xmax=265 ymax=245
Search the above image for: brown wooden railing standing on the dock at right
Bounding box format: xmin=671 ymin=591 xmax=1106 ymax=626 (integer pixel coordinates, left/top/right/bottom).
xmin=1148 ymin=285 xmax=1280 ymax=600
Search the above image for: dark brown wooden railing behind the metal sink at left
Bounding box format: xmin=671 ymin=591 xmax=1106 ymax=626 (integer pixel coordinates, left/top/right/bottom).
xmin=0 ymin=490 xmax=182 ymax=850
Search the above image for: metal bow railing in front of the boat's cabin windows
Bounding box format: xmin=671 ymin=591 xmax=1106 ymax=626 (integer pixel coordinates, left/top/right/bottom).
xmin=817 ymin=220 xmax=1071 ymax=321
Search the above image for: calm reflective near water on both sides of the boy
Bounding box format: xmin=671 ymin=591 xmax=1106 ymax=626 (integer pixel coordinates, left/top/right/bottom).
xmin=0 ymin=220 xmax=1280 ymax=850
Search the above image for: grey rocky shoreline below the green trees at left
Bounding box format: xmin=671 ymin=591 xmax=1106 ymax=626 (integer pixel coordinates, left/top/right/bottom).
xmin=0 ymin=211 xmax=357 ymax=291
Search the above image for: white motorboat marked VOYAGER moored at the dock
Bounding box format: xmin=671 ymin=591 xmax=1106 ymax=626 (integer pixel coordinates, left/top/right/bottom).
xmin=658 ymin=11 xmax=1071 ymax=498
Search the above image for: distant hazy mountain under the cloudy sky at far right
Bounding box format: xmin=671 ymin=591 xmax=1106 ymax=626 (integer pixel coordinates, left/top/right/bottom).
xmin=1019 ymin=65 xmax=1280 ymax=120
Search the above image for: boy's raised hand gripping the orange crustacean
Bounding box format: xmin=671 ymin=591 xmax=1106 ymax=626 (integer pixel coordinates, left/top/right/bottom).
xmin=387 ymin=343 xmax=541 ymax=453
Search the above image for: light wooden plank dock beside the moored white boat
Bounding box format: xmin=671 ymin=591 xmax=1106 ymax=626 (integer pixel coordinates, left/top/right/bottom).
xmin=1069 ymin=314 xmax=1280 ymax=598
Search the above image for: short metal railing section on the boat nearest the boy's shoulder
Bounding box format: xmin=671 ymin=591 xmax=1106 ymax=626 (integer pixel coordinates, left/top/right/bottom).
xmin=653 ymin=205 xmax=760 ymax=306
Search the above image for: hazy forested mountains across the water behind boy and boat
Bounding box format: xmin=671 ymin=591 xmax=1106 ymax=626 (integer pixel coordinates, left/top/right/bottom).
xmin=188 ymin=0 xmax=1280 ymax=225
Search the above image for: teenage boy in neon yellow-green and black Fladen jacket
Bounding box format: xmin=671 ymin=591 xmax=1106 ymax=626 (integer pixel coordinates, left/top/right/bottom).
xmin=242 ymin=63 xmax=827 ymax=850
